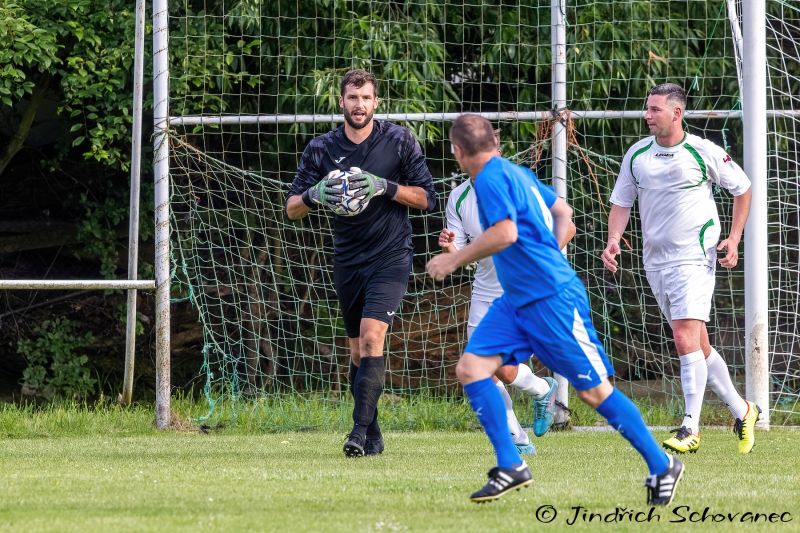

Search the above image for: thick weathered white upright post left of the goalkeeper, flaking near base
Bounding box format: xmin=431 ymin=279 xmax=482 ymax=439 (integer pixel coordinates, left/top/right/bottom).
xmin=153 ymin=0 xmax=170 ymax=429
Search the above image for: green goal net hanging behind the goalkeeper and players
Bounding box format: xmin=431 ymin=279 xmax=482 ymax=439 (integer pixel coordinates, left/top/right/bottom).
xmin=169 ymin=0 xmax=800 ymax=425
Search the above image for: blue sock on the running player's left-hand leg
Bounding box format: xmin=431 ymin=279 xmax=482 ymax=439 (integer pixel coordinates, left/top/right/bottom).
xmin=464 ymin=378 xmax=522 ymax=468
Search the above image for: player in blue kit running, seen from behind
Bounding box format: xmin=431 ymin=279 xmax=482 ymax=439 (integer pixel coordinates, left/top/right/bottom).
xmin=427 ymin=115 xmax=683 ymax=505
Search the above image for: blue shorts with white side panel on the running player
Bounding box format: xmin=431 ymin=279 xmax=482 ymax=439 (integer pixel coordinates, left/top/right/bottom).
xmin=465 ymin=277 xmax=614 ymax=391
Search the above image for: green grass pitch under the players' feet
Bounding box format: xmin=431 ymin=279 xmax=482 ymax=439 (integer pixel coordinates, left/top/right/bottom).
xmin=0 ymin=408 xmax=800 ymax=532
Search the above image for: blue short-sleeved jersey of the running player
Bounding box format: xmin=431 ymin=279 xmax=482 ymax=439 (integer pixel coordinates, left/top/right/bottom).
xmin=475 ymin=157 xmax=577 ymax=307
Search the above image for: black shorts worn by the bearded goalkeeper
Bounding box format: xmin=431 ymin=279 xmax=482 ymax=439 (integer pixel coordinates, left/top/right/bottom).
xmin=333 ymin=251 xmax=413 ymax=339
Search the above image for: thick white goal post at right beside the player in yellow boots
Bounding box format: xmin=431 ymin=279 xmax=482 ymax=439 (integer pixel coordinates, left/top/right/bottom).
xmin=742 ymin=0 xmax=770 ymax=429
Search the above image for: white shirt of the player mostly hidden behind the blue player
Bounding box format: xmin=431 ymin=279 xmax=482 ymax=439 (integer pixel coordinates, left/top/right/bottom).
xmin=445 ymin=179 xmax=503 ymax=302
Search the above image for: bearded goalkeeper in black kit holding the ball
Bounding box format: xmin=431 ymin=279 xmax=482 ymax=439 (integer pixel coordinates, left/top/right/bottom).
xmin=286 ymin=70 xmax=436 ymax=457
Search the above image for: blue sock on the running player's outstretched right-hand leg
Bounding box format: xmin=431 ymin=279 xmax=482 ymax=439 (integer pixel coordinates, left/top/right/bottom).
xmin=597 ymin=389 xmax=669 ymax=474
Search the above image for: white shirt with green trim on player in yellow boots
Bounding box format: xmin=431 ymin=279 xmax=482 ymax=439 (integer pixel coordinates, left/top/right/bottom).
xmin=611 ymin=134 xmax=750 ymax=270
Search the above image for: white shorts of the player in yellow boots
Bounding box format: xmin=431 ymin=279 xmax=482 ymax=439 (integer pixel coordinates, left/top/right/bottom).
xmin=647 ymin=265 xmax=715 ymax=325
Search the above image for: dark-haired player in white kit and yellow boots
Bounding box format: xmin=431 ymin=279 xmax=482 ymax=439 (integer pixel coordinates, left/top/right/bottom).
xmin=601 ymin=83 xmax=761 ymax=453
